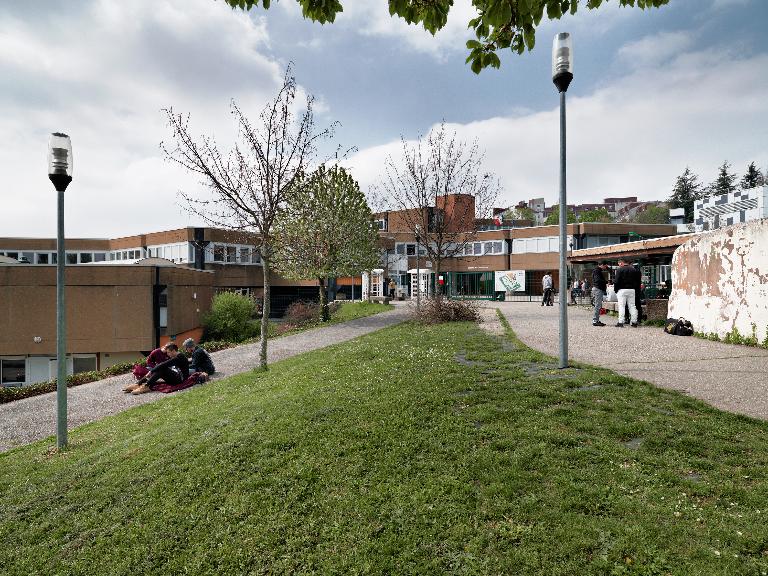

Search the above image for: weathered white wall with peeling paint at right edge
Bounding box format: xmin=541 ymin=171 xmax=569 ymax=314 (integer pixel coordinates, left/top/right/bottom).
xmin=669 ymin=219 xmax=768 ymax=341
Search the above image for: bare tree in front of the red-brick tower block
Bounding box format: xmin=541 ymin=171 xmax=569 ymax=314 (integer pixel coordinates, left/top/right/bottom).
xmin=373 ymin=123 xmax=501 ymax=293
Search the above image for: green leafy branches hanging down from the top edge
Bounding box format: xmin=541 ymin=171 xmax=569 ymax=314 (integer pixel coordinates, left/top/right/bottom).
xmin=226 ymin=0 xmax=669 ymax=74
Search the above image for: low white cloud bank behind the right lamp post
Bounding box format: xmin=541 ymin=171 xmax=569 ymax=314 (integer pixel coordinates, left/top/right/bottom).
xmin=349 ymin=44 xmax=768 ymax=212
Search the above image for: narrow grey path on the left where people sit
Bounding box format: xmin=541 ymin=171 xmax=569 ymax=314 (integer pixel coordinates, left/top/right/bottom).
xmin=0 ymin=302 xmax=411 ymax=452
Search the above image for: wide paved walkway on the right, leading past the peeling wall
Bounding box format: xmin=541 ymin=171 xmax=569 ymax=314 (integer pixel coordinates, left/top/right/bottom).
xmin=489 ymin=302 xmax=768 ymax=420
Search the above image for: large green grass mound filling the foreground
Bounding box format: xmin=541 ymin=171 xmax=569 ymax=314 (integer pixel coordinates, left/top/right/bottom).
xmin=0 ymin=324 xmax=768 ymax=576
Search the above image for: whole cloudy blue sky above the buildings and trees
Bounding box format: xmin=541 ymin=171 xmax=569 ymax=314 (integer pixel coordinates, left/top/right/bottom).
xmin=0 ymin=0 xmax=768 ymax=238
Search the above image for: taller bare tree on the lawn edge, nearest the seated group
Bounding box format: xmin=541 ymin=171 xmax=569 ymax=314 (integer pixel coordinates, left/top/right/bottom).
xmin=160 ymin=65 xmax=333 ymax=369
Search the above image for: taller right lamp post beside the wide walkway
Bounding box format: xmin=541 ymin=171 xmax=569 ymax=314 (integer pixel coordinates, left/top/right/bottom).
xmin=552 ymin=32 xmax=573 ymax=368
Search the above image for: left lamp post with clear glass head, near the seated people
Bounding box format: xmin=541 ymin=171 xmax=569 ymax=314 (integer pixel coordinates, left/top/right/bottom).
xmin=48 ymin=132 xmax=72 ymax=449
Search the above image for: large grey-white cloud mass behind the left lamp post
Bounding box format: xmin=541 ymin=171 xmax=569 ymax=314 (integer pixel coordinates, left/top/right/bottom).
xmin=0 ymin=0 xmax=282 ymax=237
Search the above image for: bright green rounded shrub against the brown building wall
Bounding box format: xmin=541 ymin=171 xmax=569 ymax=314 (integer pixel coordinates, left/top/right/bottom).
xmin=203 ymin=292 xmax=259 ymax=342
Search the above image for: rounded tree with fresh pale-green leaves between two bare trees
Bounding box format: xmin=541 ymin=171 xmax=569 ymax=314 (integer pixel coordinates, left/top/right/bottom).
xmin=274 ymin=166 xmax=379 ymax=322
